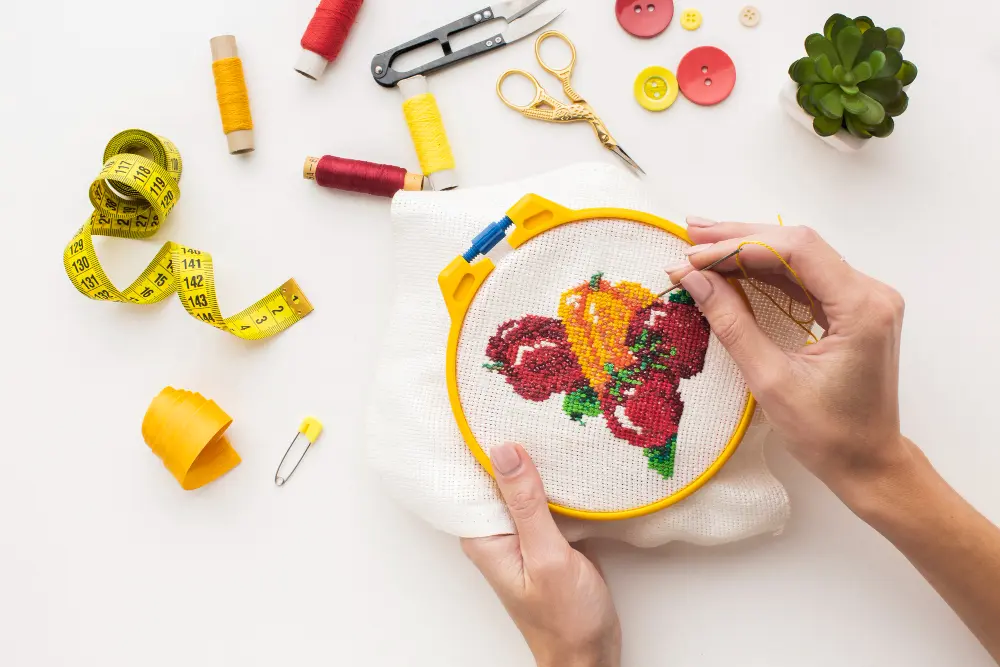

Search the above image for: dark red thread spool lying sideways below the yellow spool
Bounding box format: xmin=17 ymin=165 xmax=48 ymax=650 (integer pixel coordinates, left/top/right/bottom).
xmin=302 ymin=155 xmax=424 ymax=197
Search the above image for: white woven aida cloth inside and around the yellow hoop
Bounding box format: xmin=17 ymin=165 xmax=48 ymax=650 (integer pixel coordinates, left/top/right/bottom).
xmin=367 ymin=165 xmax=805 ymax=547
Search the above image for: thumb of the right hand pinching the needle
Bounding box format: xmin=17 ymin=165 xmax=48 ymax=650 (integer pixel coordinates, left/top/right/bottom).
xmin=681 ymin=271 xmax=789 ymax=397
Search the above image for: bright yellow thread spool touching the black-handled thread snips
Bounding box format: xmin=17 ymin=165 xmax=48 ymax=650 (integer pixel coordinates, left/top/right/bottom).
xmin=397 ymin=76 xmax=458 ymax=190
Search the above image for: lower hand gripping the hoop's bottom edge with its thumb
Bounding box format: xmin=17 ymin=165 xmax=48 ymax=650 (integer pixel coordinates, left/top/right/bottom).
xmin=462 ymin=445 xmax=622 ymax=667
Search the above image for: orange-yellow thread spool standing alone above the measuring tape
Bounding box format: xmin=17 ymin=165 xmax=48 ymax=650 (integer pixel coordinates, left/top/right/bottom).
xmin=210 ymin=35 xmax=253 ymax=155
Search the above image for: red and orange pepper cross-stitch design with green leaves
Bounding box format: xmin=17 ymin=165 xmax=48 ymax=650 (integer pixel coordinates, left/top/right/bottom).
xmin=484 ymin=274 xmax=709 ymax=479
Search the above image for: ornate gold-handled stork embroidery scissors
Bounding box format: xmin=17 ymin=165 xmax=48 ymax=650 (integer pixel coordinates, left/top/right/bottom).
xmin=497 ymin=30 xmax=646 ymax=174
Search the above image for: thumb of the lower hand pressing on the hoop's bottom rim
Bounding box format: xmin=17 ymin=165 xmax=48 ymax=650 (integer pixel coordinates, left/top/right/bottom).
xmin=490 ymin=444 xmax=569 ymax=559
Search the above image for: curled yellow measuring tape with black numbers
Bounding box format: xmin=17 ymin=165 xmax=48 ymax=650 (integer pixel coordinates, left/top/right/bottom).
xmin=63 ymin=130 xmax=313 ymax=340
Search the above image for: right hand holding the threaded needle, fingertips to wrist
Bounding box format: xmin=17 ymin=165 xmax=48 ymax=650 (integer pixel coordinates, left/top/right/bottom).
xmin=667 ymin=218 xmax=913 ymax=507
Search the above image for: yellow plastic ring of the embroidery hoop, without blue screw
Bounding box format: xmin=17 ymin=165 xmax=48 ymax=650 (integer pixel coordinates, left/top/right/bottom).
xmin=438 ymin=194 xmax=757 ymax=521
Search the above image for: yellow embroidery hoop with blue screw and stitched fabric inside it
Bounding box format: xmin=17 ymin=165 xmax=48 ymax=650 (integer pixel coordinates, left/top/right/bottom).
xmin=439 ymin=195 xmax=755 ymax=520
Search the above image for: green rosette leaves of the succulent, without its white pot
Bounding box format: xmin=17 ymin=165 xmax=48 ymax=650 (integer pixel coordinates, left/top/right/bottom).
xmin=788 ymin=14 xmax=917 ymax=139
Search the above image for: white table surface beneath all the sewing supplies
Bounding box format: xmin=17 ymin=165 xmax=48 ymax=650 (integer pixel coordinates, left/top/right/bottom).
xmin=0 ymin=0 xmax=1000 ymax=667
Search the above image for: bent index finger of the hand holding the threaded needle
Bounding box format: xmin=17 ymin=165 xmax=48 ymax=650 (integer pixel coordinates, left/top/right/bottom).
xmin=688 ymin=227 xmax=860 ymax=304
